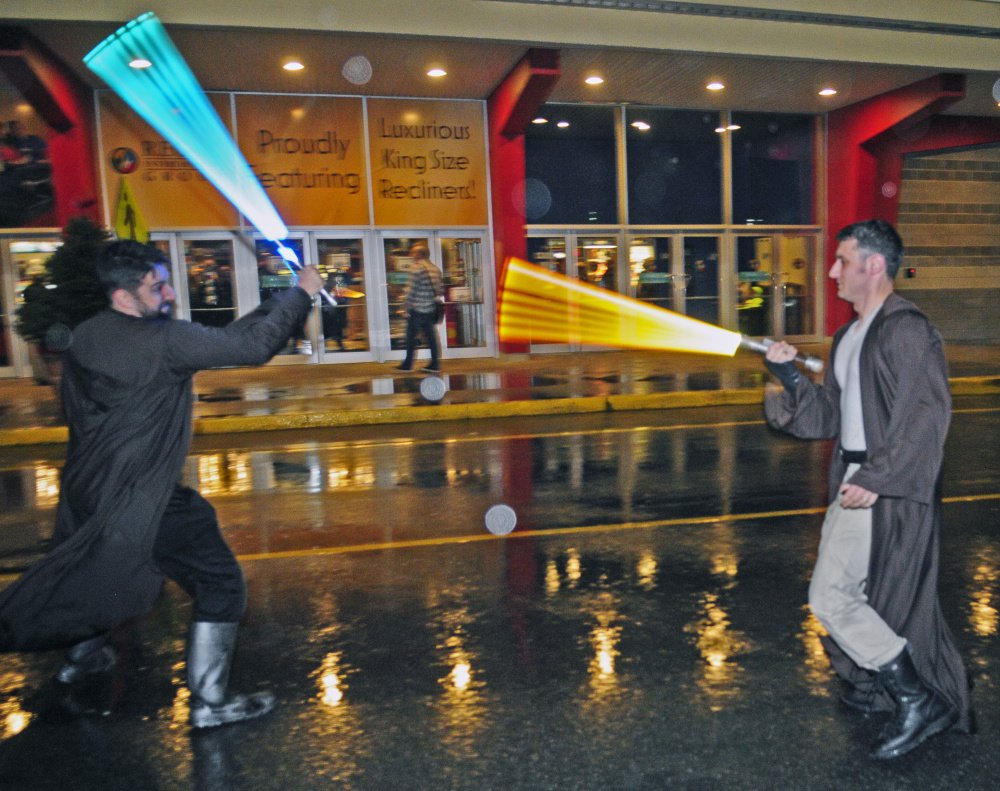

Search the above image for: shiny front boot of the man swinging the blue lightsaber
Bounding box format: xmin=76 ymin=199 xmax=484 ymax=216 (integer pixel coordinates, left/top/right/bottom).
xmin=187 ymin=621 xmax=275 ymax=728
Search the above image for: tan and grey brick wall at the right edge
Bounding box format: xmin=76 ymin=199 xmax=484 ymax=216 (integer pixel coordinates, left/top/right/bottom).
xmin=896 ymin=146 xmax=1000 ymax=343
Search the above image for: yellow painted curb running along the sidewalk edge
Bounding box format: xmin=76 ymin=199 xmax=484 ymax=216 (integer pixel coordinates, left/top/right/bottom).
xmin=0 ymin=376 xmax=1000 ymax=447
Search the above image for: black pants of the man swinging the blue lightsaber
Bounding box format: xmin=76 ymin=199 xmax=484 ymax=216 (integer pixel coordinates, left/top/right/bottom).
xmin=153 ymin=485 xmax=247 ymax=623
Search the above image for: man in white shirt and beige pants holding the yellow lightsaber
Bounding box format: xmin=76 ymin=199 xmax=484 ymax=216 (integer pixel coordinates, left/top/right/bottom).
xmin=765 ymin=220 xmax=972 ymax=759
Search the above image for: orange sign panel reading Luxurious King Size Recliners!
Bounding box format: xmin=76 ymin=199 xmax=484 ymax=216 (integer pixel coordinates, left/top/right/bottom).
xmin=368 ymin=99 xmax=489 ymax=227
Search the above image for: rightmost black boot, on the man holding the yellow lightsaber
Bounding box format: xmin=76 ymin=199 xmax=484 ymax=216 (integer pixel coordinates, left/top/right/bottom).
xmin=871 ymin=648 xmax=958 ymax=760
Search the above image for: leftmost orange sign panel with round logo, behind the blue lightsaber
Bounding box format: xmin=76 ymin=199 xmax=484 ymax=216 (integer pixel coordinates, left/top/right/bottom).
xmin=100 ymin=92 xmax=238 ymax=228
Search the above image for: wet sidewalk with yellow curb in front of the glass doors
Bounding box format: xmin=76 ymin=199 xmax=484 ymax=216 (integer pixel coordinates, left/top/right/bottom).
xmin=0 ymin=345 xmax=1000 ymax=447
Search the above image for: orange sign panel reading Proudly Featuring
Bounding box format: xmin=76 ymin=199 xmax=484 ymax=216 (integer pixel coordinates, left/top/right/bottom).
xmin=236 ymin=95 xmax=369 ymax=226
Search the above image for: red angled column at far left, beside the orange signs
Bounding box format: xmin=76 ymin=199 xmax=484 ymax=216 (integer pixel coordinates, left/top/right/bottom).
xmin=0 ymin=27 xmax=101 ymax=227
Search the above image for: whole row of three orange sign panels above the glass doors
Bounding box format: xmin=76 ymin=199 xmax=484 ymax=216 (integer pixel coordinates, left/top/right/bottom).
xmin=100 ymin=92 xmax=489 ymax=229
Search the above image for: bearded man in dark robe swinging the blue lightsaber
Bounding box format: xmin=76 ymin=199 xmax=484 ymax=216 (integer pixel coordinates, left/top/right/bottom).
xmin=0 ymin=241 xmax=322 ymax=728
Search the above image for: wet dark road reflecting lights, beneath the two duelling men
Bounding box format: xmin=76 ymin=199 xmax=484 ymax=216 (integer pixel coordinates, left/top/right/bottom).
xmin=0 ymin=392 xmax=1000 ymax=791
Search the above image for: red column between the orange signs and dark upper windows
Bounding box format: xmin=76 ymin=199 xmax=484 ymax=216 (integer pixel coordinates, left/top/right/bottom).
xmin=486 ymin=49 xmax=560 ymax=352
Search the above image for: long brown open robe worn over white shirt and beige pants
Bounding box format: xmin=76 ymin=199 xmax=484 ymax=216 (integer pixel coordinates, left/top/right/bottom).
xmin=764 ymin=294 xmax=972 ymax=731
